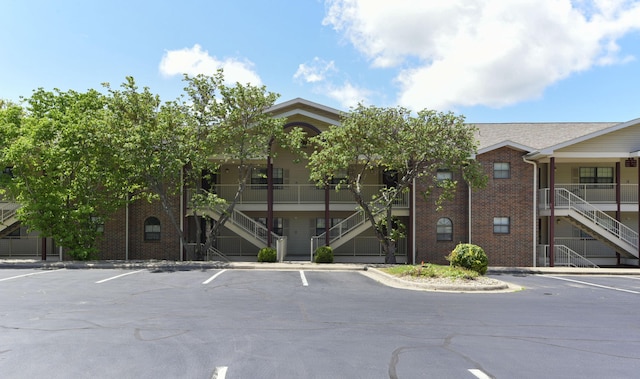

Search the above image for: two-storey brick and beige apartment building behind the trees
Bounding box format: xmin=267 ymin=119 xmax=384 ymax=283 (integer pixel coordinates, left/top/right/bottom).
xmin=0 ymin=98 xmax=640 ymax=266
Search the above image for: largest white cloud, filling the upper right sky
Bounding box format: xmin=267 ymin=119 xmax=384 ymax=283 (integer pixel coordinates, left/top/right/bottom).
xmin=323 ymin=0 xmax=640 ymax=110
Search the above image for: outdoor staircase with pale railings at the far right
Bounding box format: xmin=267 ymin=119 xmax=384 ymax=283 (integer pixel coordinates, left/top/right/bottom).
xmin=545 ymin=188 xmax=639 ymax=258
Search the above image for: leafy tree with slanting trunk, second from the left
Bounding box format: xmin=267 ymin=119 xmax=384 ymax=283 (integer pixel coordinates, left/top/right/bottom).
xmin=104 ymin=77 xmax=196 ymax=255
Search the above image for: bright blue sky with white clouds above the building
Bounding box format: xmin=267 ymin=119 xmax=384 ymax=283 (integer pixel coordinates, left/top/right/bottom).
xmin=0 ymin=0 xmax=640 ymax=122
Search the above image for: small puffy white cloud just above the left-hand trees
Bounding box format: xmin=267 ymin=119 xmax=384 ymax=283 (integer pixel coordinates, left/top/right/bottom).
xmin=159 ymin=44 xmax=262 ymax=86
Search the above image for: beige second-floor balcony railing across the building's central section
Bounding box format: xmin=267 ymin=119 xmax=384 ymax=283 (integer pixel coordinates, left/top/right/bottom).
xmin=190 ymin=184 xmax=409 ymax=208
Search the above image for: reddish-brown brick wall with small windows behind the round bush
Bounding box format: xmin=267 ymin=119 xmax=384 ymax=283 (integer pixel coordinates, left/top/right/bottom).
xmin=416 ymin=147 xmax=534 ymax=266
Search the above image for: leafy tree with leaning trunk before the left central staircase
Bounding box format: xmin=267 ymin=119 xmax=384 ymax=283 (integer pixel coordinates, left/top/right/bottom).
xmin=185 ymin=71 xmax=304 ymax=258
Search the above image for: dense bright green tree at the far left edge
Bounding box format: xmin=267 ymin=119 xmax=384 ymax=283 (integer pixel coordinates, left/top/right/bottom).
xmin=0 ymin=89 xmax=131 ymax=259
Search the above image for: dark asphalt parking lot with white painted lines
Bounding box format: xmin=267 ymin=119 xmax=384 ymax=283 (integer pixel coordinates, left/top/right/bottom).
xmin=0 ymin=269 xmax=640 ymax=379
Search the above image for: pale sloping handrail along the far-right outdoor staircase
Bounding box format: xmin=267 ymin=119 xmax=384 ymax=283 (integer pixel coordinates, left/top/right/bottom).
xmin=555 ymin=188 xmax=638 ymax=248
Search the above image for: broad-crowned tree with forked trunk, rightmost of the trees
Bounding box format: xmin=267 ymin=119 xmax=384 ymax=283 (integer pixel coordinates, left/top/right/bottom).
xmin=308 ymin=105 xmax=486 ymax=263
